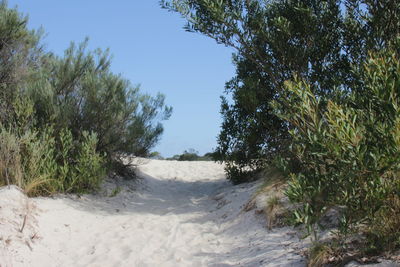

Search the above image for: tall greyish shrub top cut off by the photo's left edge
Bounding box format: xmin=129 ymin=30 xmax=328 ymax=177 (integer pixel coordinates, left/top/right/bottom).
xmin=0 ymin=1 xmax=42 ymax=125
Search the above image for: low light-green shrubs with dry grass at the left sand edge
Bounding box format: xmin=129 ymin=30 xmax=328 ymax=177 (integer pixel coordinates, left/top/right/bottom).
xmin=0 ymin=124 xmax=104 ymax=196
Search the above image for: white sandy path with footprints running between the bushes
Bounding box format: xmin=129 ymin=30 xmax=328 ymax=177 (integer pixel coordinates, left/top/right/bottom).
xmin=0 ymin=160 xmax=305 ymax=267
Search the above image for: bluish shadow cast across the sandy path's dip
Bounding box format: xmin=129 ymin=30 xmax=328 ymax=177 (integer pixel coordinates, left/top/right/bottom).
xmin=46 ymin=171 xmax=231 ymax=219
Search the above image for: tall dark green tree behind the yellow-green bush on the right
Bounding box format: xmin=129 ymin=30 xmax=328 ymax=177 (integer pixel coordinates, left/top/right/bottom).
xmin=161 ymin=0 xmax=400 ymax=182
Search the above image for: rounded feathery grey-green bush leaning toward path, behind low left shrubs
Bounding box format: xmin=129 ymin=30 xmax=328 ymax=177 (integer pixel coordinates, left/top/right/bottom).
xmin=31 ymin=42 xmax=172 ymax=159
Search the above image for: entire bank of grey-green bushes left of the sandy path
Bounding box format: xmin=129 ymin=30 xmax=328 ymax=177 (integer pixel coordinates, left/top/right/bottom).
xmin=0 ymin=1 xmax=171 ymax=195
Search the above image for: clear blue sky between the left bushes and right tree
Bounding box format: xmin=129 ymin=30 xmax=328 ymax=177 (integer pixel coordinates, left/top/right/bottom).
xmin=8 ymin=0 xmax=234 ymax=156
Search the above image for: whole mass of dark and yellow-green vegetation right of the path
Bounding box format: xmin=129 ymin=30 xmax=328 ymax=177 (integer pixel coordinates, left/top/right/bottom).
xmin=161 ymin=0 xmax=400 ymax=264
